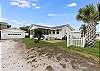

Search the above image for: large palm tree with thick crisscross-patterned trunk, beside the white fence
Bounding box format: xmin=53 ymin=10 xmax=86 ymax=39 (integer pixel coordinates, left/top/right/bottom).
xmin=76 ymin=4 xmax=99 ymax=47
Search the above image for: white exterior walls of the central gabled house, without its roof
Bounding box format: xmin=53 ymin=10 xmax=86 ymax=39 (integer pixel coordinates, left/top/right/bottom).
xmin=30 ymin=25 xmax=71 ymax=39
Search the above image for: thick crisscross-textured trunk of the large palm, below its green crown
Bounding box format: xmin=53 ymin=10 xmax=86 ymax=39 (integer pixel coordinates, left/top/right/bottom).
xmin=86 ymin=23 xmax=96 ymax=47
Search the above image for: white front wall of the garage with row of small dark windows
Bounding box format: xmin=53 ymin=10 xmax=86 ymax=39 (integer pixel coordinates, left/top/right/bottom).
xmin=1 ymin=30 xmax=25 ymax=39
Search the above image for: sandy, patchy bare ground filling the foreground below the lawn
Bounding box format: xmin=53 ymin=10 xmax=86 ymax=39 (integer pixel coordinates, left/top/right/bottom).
xmin=0 ymin=40 xmax=99 ymax=71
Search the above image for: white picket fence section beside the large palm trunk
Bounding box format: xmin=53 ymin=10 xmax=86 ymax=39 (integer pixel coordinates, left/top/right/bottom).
xmin=67 ymin=31 xmax=85 ymax=47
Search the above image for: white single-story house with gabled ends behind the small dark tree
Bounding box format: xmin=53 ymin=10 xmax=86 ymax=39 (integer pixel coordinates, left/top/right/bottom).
xmin=29 ymin=24 xmax=74 ymax=39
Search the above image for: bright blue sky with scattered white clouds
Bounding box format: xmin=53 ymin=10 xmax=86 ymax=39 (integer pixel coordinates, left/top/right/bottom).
xmin=0 ymin=0 xmax=100 ymax=31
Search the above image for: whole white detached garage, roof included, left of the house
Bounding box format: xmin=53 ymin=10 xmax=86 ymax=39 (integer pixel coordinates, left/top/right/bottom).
xmin=0 ymin=28 xmax=25 ymax=39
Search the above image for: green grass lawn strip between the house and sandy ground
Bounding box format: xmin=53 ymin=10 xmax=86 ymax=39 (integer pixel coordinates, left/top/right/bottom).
xmin=23 ymin=38 xmax=100 ymax=61
